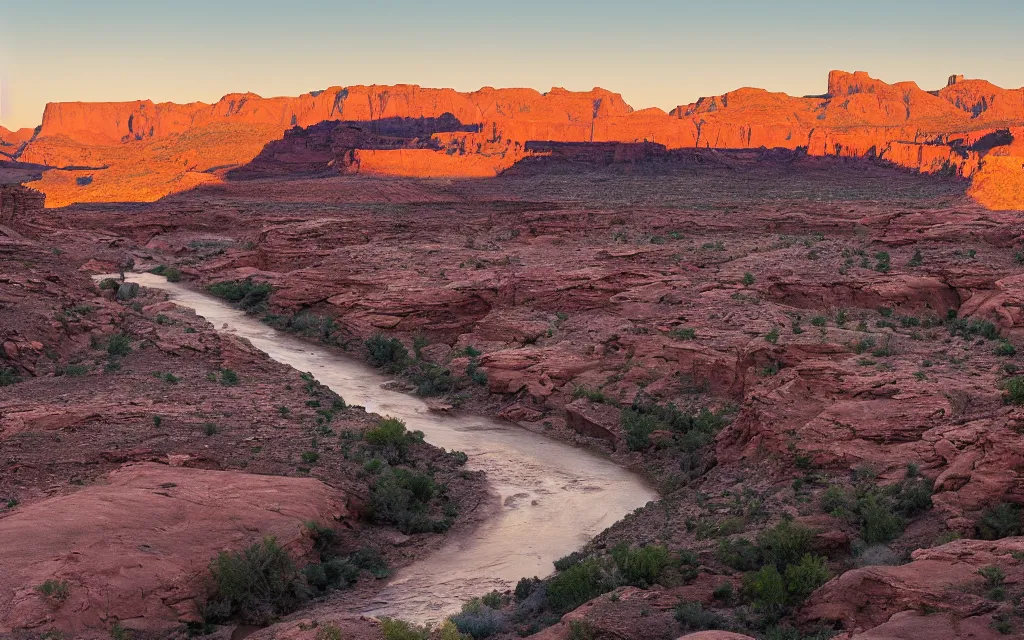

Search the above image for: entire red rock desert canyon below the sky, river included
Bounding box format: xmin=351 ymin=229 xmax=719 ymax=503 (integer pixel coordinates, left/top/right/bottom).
xmin=0 ymin=71 xmax=1024 ymax=640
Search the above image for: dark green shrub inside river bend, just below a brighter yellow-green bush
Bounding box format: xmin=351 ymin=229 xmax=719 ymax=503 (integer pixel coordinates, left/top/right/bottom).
xmin=370 ymin=468 xmax=443 ymax=534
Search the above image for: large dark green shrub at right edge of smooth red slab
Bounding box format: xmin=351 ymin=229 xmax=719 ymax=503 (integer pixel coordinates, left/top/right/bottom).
xmin=207 ymin=536 xmax=303 ymax=625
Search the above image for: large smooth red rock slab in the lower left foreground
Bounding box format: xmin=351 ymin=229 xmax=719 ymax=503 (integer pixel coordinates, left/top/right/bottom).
xmin=0 ymin=463 xmax=347 ymax=633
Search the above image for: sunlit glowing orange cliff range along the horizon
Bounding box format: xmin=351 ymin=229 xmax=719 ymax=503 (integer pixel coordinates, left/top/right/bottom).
xmin=16 ymin=71 xmax=1024 ymax=208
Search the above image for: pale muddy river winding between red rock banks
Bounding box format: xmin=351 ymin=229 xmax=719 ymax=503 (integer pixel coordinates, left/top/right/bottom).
xmin=112 ymin=273 xmax=657 ymax=622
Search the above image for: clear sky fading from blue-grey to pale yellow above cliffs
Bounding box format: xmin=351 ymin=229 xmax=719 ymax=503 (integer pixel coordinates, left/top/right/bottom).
xmin=0 ymin=0 xmax=1024 ymax=128
